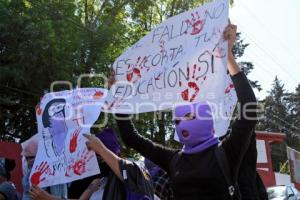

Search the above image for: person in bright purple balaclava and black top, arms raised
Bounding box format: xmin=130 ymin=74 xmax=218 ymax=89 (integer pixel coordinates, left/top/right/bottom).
xmin=117 ymin=24 xmax=256 ymax=200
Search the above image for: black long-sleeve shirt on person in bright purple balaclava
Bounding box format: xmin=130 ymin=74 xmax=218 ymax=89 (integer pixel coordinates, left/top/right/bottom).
xmin=117 ymin=72 xmax=256 ymax=200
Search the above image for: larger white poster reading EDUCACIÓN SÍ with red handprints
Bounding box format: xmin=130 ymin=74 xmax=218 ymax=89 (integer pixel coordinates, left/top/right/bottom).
xmin=105 ymin=0 xmax=236 ymax=118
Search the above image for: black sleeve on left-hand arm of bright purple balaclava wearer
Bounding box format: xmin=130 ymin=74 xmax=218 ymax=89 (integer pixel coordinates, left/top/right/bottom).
xmin=116 ymin=114 xmax=176 ymax=172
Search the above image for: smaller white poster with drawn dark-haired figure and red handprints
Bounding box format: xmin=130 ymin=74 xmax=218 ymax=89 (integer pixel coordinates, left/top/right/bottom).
xmin=30 ymin=88 xmax=107 ymax=187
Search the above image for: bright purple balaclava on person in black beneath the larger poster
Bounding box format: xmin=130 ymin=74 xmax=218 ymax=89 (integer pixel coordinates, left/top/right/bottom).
xmin=175 ymin=103 xmax=219 ymax=154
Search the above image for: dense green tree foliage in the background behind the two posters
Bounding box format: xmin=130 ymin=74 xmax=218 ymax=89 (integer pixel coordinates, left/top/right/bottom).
xmin=0 ymin=0 xmax=274 ymax=154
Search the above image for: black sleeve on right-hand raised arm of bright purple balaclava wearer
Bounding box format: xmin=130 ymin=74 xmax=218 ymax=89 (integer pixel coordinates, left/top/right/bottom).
xmin=222 ymin=72 xmax=257 ymax=170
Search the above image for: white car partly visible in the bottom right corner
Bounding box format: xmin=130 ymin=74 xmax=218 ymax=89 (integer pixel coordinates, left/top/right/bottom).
xmin=267 ymin=185 xmax=300 ymax=200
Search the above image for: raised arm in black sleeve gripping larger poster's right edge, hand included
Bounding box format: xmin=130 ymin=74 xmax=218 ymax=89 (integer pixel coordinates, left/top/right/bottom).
xmin=222 ymin=24 xmax=257 ymax=166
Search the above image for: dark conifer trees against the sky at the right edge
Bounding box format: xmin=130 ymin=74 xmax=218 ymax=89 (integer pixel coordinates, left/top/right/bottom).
xmin=257 ymin=76 xmax=300 ymax=171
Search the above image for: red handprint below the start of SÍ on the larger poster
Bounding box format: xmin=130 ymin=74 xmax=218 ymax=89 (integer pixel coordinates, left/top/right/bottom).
xmin=179 ymin=63 xmax=206 ymax=102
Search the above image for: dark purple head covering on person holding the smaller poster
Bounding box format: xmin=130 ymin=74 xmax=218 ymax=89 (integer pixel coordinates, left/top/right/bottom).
xmin=96 ymin=128 xmax=121 ymax=154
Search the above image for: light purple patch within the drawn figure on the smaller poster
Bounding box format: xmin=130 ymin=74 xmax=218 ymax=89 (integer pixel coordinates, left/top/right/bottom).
xmin=49 ymin=112 xmax=67 ymax=155
